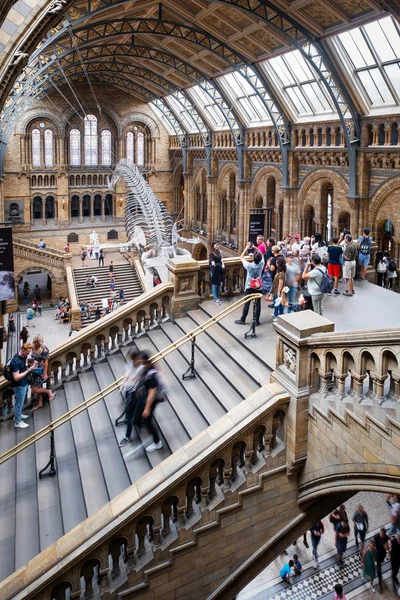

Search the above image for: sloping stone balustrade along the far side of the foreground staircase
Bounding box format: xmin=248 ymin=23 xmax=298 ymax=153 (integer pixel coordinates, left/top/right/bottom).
xmin=0 ymin=283 xmax=174 ymax=420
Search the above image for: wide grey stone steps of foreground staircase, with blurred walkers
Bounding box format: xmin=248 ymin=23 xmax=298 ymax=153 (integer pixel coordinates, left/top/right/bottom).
xmin=0 ymin=304 xmax=270 ymax=581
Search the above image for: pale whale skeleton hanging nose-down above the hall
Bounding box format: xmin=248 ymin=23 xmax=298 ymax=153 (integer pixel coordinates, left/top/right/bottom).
xmin=108 ymin=158 xmax=201 ymax=269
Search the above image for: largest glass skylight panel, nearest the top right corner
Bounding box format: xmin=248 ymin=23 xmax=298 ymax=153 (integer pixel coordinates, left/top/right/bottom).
xmin=335 ymin=17 xmax=400 ymax=112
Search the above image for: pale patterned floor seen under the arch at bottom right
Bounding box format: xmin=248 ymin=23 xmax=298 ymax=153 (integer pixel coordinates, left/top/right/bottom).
xmin=237 ymin=492 xmax=394 ymax=600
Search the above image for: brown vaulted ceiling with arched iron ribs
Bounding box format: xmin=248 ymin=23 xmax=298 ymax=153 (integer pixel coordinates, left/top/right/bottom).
xmin=0 ymin=0 xmax=400 ymax=141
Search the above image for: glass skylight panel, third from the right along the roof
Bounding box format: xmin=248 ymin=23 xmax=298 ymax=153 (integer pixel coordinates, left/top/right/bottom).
xmin=218 ymin=72 xmax=272 ymax=126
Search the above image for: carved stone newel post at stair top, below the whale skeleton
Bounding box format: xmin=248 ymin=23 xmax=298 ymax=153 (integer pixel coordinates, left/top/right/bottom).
xmin=167 ymin=256 xmax=200 ymax=318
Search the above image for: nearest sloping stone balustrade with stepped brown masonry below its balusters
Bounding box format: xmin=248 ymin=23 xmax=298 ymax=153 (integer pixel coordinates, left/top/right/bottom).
xmin=2 ymin=382 xmax=288 ymax=600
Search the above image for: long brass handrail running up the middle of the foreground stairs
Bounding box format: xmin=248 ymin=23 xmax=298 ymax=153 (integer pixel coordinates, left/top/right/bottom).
xmin=0 ymin=293 xmax=262 ymax=465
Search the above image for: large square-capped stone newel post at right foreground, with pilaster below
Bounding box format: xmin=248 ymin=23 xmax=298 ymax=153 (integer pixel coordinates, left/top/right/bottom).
xmin=271 ymin=310 xmax=335 ymax=472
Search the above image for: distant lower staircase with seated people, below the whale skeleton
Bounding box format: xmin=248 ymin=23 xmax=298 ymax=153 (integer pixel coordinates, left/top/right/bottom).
xmin=73 ymin=261 xmax=143 ymax=327
